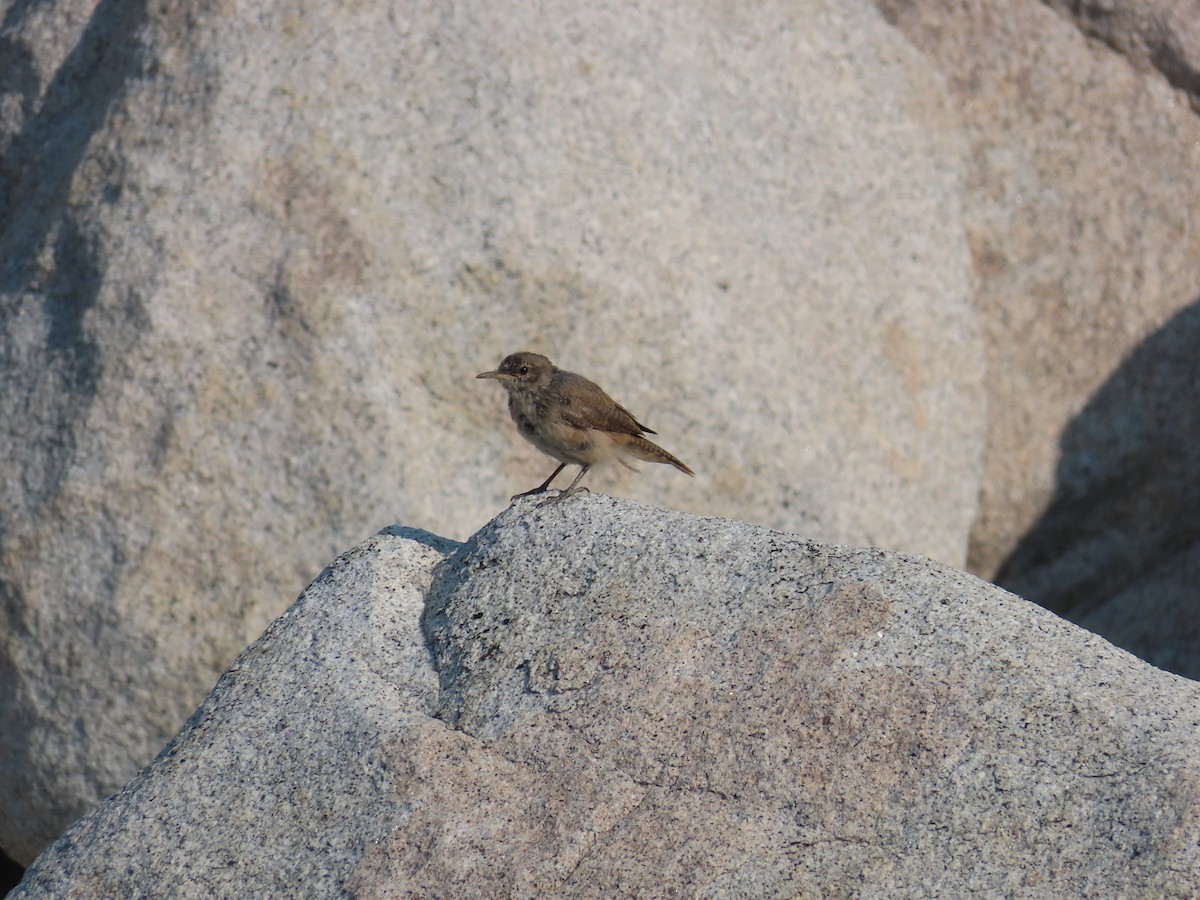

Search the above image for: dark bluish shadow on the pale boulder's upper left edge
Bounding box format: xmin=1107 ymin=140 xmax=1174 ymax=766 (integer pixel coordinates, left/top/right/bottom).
xmin=0 ymin=0 xmax=152 ymax=511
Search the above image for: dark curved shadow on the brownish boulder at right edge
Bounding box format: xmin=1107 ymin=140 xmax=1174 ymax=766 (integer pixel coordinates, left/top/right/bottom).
xmin=996 ymin=301 xmax=1200 ymax=678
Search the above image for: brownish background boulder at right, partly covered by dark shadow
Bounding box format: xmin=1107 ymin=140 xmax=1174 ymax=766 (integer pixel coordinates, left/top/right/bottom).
xmin=877 ymin=0 xmax=1200 ymax=677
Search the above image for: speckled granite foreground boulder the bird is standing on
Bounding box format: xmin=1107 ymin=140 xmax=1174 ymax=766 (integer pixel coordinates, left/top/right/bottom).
xmin=9 ymin=494 xmax=1200 ymax=898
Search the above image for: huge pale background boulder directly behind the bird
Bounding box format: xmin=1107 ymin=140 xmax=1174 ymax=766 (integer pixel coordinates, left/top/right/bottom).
xmin=0 ymin=0 xmax=984 ymax=862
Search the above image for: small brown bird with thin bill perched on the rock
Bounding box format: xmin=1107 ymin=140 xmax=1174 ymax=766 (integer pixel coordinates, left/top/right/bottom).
xmin=475 ymin=352 xmax=695 ymax=499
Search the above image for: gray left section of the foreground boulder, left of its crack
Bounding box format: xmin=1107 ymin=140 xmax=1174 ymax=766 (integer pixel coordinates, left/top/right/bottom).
xmin=18 ymin=529 xmax=454 ymax=896
